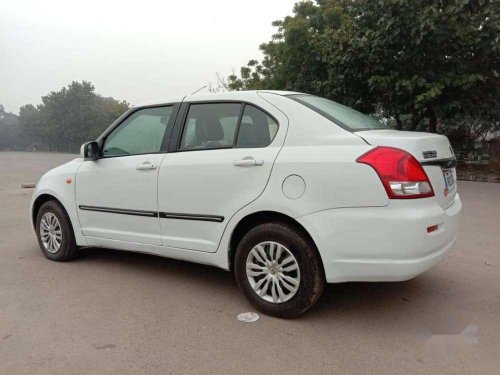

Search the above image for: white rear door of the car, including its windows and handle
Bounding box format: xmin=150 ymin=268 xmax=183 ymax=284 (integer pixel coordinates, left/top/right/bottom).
xmin=158 ymin=100 xmax=288 ymax=252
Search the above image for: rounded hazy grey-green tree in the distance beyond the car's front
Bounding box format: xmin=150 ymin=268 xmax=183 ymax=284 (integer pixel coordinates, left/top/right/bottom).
xmin=8 ymin=81 xmax=129 ymax=152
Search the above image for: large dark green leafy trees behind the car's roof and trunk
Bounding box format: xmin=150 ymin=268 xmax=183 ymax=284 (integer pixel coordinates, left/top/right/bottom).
xmin=228 ymin=0 xmax=500 ymax=131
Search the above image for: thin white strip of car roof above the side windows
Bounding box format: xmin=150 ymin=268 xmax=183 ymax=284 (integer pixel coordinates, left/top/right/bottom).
xmin=133 ymin=90 xmax=301 ymax=107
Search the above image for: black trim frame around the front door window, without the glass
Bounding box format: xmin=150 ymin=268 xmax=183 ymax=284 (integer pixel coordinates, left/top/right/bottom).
xmin=96 ymin=102 xmax=182 ymax=159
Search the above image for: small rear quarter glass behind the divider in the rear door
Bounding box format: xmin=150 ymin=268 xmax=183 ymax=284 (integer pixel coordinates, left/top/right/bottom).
xmin=236 ymin=104 xmax=278 ymax=147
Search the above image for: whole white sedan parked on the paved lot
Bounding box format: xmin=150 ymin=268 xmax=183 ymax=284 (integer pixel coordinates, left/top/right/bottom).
xmin=30 ymin=91 xmax=462 ymax=317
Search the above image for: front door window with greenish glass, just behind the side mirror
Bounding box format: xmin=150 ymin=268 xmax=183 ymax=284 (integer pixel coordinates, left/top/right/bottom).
xmin=102 ymin=106 xmax=173 ymax=157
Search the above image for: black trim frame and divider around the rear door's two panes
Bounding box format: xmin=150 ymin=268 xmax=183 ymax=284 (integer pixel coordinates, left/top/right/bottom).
xmin=168 ymin=99 xmax=280 ymax=152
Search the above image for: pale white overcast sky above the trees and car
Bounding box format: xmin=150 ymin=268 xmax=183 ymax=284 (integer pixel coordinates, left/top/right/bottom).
xmin=0 ymin=0 xmax=296 ymax=113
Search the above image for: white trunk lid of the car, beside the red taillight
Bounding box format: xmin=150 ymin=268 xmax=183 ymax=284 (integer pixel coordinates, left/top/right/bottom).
xmin=354 ymin=129 xmax=457 ymax=209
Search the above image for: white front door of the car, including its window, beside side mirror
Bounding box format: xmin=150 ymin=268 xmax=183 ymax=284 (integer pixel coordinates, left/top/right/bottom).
xmin=76 ymin=106 xmax=175 ymax=245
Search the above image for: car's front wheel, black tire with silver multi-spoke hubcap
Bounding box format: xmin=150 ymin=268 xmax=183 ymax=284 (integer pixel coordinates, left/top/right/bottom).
xmin=36 ymin=201 xmax=78 ymax=262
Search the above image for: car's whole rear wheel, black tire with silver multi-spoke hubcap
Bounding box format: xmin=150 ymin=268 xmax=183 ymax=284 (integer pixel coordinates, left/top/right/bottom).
xmin=235 ymin=222 xmax=325 ymax=318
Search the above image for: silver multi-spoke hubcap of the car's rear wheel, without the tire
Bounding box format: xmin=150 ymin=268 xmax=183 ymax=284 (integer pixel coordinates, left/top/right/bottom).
xmin=246 ymin=241 xmax=300 ymax=303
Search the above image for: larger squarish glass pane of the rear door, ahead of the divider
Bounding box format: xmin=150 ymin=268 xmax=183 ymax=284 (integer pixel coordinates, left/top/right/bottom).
xmin=179 ymin=103 xmax=241 ymax=150
